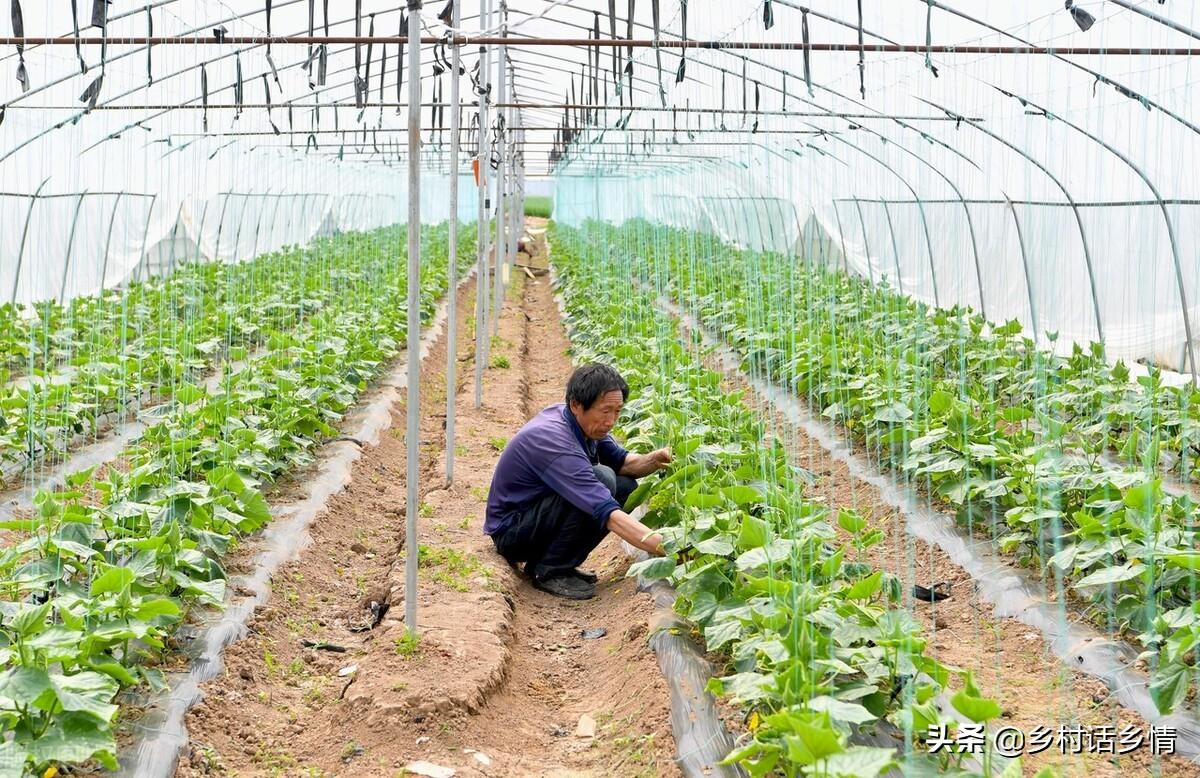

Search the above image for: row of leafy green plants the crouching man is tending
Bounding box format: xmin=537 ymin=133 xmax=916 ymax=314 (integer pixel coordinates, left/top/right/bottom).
xmin=552 ymin=226 xmax=1020 ymax=777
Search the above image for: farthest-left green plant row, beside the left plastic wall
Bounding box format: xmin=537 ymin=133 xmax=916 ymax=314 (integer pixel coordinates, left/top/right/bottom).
xmin=0 ymin=229 xmax=408 ymax=475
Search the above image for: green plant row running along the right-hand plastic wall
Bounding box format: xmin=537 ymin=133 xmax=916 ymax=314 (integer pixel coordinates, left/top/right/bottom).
xmin=596 ymin=216 xmax=1200 ymax=713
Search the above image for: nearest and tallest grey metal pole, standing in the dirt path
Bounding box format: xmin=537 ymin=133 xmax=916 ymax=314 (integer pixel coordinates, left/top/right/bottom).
xmin=404 ymin=0 xmax=421 ymax=635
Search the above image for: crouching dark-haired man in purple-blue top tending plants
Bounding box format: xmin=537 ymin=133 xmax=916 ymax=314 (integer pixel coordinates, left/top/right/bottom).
xmin=484 ymin=363 xmax=671 ymax=599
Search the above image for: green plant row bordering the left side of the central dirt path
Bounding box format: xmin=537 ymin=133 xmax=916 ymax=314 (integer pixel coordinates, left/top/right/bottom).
xmin=0 ymin=227 xmax=472 ymax=777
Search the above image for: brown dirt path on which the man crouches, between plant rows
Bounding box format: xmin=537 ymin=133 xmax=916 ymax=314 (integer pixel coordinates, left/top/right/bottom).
xmin=176 ymin=224 xmax=678 ymax=778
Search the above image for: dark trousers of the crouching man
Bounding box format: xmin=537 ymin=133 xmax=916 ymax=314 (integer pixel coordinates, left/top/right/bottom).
xmin=492 ymin=465 xmax=637 ymax=580
